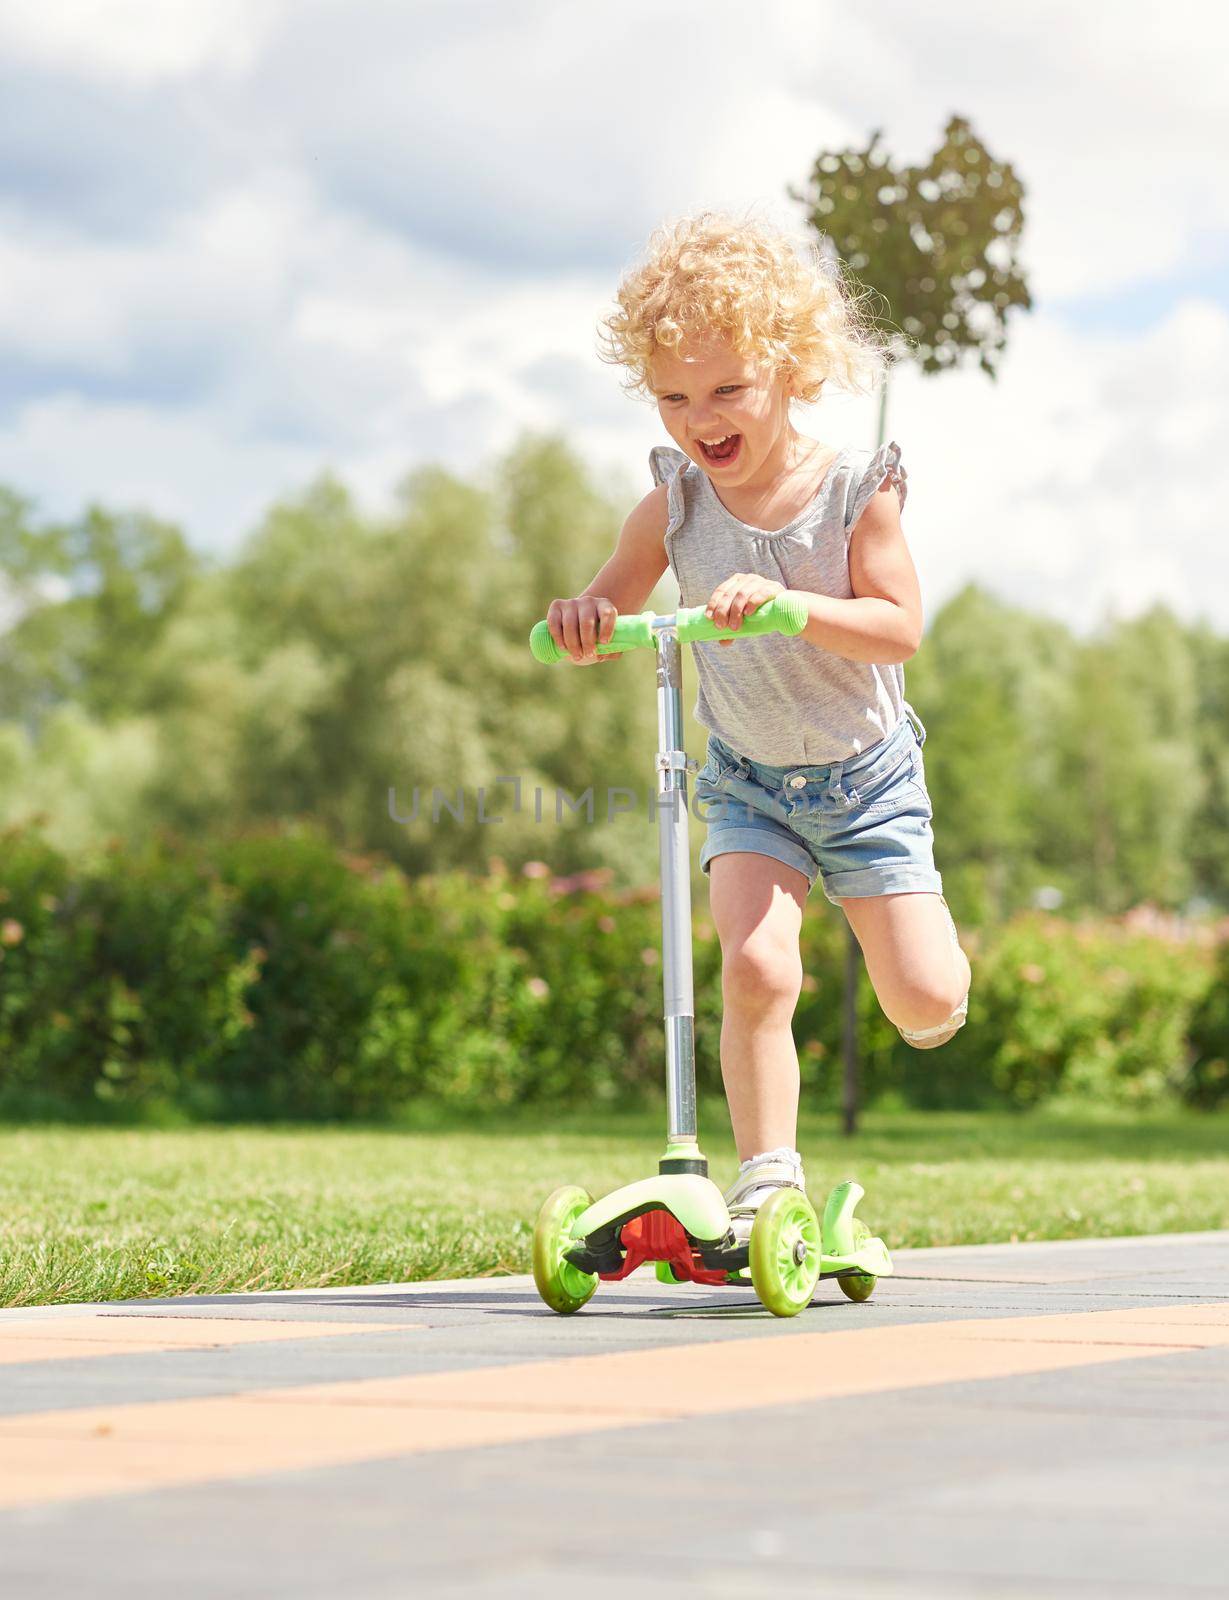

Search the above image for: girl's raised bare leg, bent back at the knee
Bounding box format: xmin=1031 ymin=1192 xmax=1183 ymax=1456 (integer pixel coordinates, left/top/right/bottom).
xmin=840 ymin=894 xmax=970 ymax=1050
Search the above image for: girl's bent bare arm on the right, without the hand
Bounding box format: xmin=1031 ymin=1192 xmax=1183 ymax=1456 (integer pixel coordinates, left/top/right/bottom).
xmin=799 ymin=483 xmax=922 ymax=666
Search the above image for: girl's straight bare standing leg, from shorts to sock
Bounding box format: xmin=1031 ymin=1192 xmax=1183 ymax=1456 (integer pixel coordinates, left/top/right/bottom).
xmin=709 ymin=851 xmax=807 ymax=1162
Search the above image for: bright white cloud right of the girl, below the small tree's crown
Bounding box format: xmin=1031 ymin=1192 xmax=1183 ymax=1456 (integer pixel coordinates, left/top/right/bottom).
xmin=870 ymin=301 xmax=1229 ymax=630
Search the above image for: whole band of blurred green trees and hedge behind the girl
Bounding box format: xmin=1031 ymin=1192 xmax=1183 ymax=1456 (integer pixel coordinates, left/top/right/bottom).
xmin=0 ymin=435 xmax=1229 ymax=1117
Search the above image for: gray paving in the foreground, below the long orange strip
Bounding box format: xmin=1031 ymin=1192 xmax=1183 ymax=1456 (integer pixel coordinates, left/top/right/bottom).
xmin=3 ymin=1357 xmax=1226 ymax=1597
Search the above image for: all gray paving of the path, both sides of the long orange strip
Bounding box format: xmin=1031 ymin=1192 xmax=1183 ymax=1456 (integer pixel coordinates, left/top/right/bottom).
xmin=0 ymin=1232 xmax=1229 ymax=1600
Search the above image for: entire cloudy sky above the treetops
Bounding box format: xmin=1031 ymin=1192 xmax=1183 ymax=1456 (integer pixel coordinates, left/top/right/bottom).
xmin=0 ymin=0 xmax=1229 ymax=630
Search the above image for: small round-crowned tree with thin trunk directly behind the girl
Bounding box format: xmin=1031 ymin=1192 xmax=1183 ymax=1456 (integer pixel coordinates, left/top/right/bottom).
xmin=789 ymin=117 xmax=1032 ymax=1133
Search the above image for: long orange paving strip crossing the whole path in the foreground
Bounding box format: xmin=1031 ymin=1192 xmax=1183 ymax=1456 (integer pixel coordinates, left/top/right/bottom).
xmin=0 ymin=1304 xmax=1229 ymax=1506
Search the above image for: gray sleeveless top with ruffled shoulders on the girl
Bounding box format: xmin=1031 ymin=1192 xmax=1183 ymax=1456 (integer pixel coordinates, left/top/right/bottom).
xmin=648 ymin=443 xmax=906 ymax=766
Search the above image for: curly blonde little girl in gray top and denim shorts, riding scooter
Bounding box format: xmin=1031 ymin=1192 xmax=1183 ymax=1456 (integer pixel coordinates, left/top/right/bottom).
xmin=547 ymin=213 xmax=970 ymax=1238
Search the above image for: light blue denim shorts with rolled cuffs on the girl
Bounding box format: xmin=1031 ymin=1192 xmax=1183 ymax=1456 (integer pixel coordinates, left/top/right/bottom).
xmin=695 ymin=706 xmax=943 ymax=906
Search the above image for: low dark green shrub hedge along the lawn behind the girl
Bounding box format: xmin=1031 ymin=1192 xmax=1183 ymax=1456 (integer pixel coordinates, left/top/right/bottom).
xmin=0 ymin=827 xmax=1229 ymax=1118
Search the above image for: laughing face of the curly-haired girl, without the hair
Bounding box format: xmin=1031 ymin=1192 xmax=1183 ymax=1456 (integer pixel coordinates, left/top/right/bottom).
xmin=650 ymin=339 xmax=789 ymax=488
